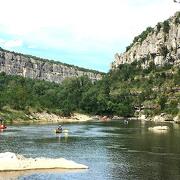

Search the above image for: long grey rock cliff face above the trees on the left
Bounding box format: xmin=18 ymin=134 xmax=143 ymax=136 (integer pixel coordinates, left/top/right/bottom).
xmin=0 ymin=49 xmax=102 ymax=83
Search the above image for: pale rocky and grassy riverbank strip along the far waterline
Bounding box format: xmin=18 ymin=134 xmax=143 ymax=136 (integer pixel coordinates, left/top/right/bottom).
xmin=0 ymin=108 xmax=180 ymax=124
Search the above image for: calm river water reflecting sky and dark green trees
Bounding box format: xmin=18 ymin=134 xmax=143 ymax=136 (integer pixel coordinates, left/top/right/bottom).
xmin=0 ymin=120 xmax=180 ymax=180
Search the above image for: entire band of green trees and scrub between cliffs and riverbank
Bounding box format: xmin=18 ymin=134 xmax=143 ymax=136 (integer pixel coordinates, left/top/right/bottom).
xmin=0 ymin=61 xmax=180 ymax=120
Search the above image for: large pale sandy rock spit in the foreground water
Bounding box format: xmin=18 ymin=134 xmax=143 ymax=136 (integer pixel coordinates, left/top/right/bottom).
xmin=0 ymin=152 xmax=88 ymax=171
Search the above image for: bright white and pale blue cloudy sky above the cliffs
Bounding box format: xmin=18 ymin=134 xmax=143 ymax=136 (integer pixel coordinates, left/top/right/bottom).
xmin=0 ymin=0 xmax=180 ymax=72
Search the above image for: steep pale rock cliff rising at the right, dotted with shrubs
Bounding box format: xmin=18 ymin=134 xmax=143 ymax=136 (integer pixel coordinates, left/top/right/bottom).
xmin=112 ymin=12 xmax=180 ymax=69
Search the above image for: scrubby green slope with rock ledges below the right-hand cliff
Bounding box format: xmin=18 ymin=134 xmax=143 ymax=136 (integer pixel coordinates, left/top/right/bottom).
xmin=110 ymin=61 xmax=180 ymax=117
